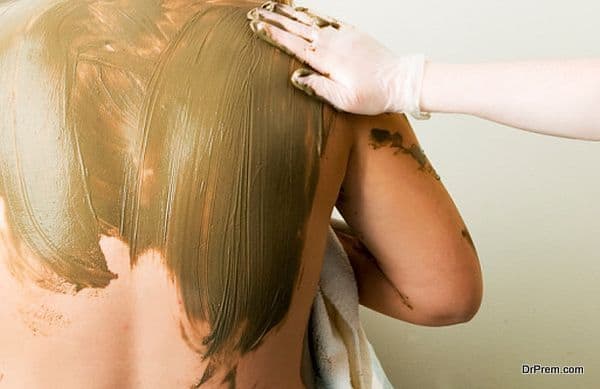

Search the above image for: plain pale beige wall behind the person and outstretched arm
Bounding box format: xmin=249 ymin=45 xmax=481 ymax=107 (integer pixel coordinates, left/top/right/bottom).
xmin=297 ymin=0 xmax=600 ymax=389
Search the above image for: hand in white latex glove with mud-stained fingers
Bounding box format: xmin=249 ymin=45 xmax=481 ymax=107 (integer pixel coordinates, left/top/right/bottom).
xmin=248 ymin=1 xmax=429 ymax=119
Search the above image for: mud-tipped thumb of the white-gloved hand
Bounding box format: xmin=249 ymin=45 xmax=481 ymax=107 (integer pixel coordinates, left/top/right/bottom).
xmin=291 ymin=68 xmax=343 ymax=110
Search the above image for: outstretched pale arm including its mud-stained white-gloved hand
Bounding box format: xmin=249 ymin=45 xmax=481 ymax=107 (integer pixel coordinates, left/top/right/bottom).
xmin=248 ymin=2 xmax=600 ymax=140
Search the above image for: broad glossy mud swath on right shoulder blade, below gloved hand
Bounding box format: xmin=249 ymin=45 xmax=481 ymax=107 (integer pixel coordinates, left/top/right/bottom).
xmin=126 ymin=2 xmax=326 ymax=374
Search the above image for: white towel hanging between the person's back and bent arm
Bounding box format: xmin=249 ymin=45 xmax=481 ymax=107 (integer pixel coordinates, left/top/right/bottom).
xmin=309 ymin=227 xmax=393 ymax=389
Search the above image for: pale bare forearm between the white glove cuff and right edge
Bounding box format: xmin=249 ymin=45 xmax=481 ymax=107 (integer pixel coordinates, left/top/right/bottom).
xmin=421 ymin=60 xmax=600 ymax=140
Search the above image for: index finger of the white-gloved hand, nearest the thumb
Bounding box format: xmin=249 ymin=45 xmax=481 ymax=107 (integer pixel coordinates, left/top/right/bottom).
xmin=250 ymin=19 xmax=328 ymax=75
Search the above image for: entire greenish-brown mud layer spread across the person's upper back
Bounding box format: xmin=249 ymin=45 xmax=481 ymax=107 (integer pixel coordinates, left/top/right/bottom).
xmin=0 ymin=0 xmax=326 ymax=372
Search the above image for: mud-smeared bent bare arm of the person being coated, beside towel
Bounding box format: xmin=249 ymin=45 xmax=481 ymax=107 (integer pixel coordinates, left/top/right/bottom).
xmin=336 ymin=110 xmax=483 ymax=326
